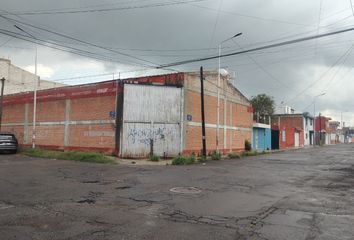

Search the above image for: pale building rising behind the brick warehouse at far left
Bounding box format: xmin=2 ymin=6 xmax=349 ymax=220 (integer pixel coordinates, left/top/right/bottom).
xmin=0 ymin=58 xmax=65 ymax=95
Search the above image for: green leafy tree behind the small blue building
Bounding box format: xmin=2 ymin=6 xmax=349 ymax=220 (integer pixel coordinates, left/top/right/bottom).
xmin=251 ymin=94 xmax=275 ymax=123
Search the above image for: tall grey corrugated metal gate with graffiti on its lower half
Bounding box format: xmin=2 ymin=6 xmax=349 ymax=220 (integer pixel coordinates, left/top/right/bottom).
xmin=121 ymin=84 xmax=182 ymax=158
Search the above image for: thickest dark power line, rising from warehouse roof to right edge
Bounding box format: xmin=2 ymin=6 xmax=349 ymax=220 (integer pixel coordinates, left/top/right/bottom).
xmin=157 ymin=25 xmax=354 ymax=68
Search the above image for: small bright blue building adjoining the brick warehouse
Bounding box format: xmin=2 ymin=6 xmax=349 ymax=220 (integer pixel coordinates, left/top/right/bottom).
xmin=252 ymin=123 xmax=272 ymax=151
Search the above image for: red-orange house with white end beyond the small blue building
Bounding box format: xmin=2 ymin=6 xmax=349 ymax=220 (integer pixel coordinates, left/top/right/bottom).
xmin=272 ymin=113 xmax=313 ymax=149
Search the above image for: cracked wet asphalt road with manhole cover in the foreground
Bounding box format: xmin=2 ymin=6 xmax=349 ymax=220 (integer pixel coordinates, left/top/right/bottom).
xmin=0 ymin=145 xmax=354 ymax=240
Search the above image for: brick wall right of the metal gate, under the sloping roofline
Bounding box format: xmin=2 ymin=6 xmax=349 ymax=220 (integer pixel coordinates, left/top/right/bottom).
xmin=184 ymin=73 xmax=252 ymax=154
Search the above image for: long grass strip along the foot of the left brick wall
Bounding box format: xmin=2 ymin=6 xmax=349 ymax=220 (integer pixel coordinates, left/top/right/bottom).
xmin=19 ymin=148 xmax=115 ymax=164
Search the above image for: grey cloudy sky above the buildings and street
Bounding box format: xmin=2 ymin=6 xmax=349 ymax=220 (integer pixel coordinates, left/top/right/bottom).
xmin=0 ymin=0 xmax=354 ymax=125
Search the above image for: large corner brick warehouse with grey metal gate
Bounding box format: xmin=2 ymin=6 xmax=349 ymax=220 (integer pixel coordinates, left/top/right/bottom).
xmin=3 ymin=71 xmax=253 ymax=158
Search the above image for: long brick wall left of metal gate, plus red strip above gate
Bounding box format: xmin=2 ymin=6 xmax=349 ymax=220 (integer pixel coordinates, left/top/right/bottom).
xmin=2 ymin=74 xmax=183 ymax=156
